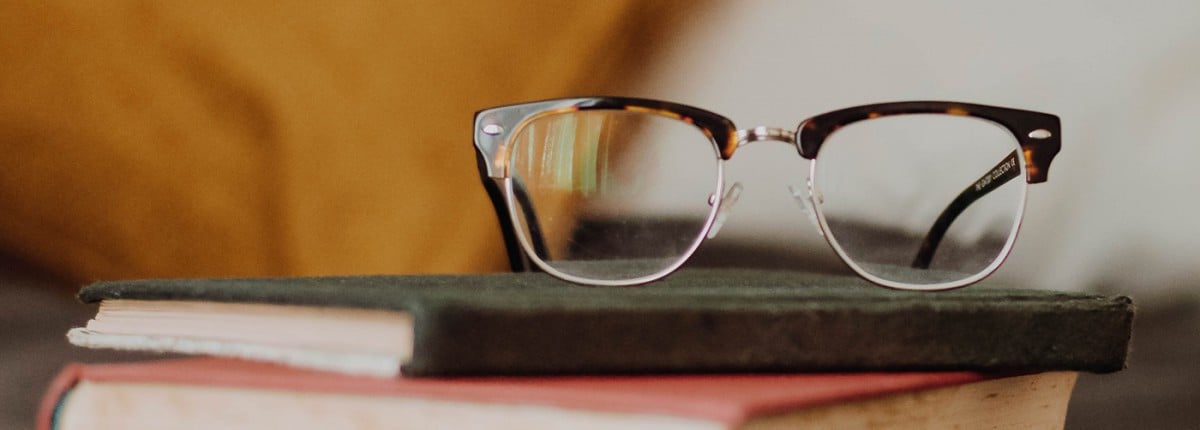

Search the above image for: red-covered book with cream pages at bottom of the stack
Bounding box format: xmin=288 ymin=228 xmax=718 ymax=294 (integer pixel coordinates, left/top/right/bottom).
xmin=38 ymin=359 xmax=1075 ymax=429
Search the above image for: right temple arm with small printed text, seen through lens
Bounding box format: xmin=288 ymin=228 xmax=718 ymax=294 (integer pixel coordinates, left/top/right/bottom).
xmin=912 ymin=150 xmax=1021 ymax=269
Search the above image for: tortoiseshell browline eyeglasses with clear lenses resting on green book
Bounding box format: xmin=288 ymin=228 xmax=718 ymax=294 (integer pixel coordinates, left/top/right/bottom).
xmin=474 ymin=97 xmax=1061 ymax=291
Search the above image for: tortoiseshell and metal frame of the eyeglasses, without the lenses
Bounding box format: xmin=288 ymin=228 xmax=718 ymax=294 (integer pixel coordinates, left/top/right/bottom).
xmin=474 ymin=97 xmax=1062 ymax=291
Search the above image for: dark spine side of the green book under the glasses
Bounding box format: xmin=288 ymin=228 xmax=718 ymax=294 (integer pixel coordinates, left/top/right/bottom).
xmin=401 ymin=303 xmax=1133 ymax=376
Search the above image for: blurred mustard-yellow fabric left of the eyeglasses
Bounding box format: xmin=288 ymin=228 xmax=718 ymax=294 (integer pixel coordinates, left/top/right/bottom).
xmin=0 ymin=0 xmax=684 ymax=280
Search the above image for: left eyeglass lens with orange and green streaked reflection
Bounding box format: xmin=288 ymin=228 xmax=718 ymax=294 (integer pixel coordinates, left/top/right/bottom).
xmin=509 ymin=109 xmax=720 ymax=281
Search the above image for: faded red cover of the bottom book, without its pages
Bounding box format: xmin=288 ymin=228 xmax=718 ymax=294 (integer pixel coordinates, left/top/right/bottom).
xmin=37 ymin=358 xmax=995 ymax=430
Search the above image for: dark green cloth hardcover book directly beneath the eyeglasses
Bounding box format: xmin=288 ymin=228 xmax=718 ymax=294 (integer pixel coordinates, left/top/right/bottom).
xmin=68 ymin=269 xmax=1134 ymax=376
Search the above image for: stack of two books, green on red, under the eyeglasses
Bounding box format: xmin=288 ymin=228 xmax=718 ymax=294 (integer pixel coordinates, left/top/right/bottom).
xmin=38 ymin=270 xmax=1133 ymax=429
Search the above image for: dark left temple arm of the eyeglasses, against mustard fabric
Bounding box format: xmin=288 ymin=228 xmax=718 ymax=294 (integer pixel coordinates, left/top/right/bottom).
xmin=475 ymin=153 xmax=546 ymax=271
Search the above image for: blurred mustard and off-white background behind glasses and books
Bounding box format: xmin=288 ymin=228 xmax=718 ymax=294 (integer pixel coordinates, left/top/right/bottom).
xmin=0 ymin=0 xmax=1200 ymax=429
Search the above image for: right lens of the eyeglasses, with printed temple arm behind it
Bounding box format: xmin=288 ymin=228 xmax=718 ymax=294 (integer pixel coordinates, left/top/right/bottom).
xmin=812 ymin=114 xmax=1026 ymax=288
